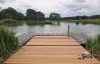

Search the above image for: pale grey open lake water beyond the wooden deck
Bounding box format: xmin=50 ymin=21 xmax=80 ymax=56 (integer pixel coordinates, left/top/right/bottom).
xmin=9 ymin=22 xmax=100 ymax=36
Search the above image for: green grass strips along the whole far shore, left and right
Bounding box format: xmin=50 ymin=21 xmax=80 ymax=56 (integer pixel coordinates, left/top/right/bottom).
xmin=0 ymin=19 xmax=100 ymax=26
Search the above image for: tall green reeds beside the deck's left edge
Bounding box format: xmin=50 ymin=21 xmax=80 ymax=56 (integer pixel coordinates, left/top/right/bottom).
xmin=0 ymin=26 xmax=19 ymax=59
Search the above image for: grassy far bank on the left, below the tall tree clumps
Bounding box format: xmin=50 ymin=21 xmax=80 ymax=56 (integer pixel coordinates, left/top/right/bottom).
xmin=0 ymin=19 xmax=53 ymax=26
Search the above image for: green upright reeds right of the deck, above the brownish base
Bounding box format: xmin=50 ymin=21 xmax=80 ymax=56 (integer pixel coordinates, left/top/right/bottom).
xmin=86 ymin=35 xmax=100 ymax=53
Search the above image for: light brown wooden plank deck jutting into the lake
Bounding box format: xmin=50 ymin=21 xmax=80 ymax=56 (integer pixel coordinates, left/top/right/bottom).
xmin=5 ymin=36 xmax=99 ymax=64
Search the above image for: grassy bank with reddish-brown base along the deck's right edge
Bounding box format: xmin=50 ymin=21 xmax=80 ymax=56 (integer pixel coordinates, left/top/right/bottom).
xmin=86 ymin=34 xmax=100 ymax=60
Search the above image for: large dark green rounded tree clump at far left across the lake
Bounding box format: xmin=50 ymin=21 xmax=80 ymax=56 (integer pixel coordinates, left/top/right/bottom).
xmin=0 ymin=7 xmax=24 ymax=20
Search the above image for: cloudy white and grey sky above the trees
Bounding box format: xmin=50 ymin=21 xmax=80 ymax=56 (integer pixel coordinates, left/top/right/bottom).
xmin=0 ymin=0 xmax=100 ymax=17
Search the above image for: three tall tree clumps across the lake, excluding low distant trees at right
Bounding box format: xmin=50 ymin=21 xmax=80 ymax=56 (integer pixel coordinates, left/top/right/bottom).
xmin=0 ymin=7 xmax=61 ymax=20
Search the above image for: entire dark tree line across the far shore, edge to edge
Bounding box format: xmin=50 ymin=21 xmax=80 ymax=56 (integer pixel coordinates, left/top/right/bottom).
xmin=0 ymin=7 xmax=100 ymax=20
